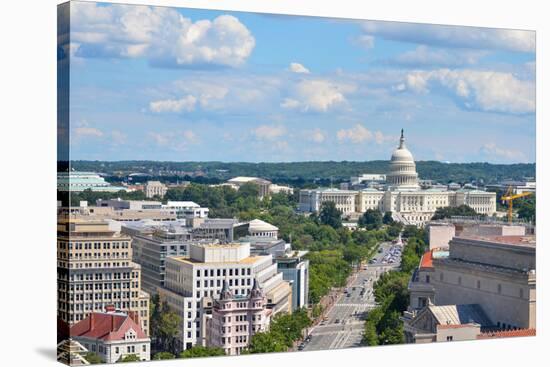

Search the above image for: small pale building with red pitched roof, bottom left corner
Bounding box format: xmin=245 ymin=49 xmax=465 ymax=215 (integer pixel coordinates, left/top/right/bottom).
xmin=70 ymin=308 xmax=151 ymax=363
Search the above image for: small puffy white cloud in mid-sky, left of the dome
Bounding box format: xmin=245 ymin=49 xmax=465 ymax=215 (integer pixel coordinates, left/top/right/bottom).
xmin=281 ymin=79 xmax=356 ymax=112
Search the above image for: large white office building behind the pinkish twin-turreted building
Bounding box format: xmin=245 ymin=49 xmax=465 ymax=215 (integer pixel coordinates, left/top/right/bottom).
xmin=159 ymin=243 xmax=292 ymax=349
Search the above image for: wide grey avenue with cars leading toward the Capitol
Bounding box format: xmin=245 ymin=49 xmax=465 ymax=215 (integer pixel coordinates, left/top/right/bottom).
xmin=301 ymin=242 xmax=406 ymax=351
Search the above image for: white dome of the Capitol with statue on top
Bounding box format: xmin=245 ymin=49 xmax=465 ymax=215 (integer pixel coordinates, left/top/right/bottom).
xmin=386 ymin=129 xmax=419 ymax=189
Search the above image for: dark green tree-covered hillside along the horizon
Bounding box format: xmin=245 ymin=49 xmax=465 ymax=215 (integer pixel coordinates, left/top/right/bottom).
xmin=68 ymin=161 xmax=535 ymax=187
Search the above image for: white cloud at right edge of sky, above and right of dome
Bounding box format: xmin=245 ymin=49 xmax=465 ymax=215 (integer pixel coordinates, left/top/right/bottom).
xmin=406 ymin=69 xmax=535 ymax=114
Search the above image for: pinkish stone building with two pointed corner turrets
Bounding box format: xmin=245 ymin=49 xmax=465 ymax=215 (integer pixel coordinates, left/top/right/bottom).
xmin=206 ymin=280 xmax=271 ymax=355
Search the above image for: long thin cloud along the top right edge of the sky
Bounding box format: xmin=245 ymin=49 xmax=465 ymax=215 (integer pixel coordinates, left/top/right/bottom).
xmin=362 ymin=21 xmax=536 ymax=52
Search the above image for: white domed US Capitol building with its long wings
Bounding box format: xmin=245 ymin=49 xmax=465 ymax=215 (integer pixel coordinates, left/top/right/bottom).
xmin=299 ymin=130 xmax=496 ymax=226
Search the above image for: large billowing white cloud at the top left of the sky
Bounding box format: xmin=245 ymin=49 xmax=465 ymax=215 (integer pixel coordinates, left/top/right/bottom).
xmin=71 ymin=2 xmax=255 ymax=67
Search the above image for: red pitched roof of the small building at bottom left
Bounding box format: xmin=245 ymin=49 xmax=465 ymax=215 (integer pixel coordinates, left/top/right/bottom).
xmin=71 ymin=312 xmax=147 ymax=341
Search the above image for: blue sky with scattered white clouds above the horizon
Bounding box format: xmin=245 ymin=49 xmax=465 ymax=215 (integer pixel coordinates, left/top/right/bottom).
xmin=62 ymin=2 xmax=535 ymax=163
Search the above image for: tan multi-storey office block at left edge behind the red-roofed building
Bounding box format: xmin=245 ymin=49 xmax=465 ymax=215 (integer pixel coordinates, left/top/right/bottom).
xmin=57 ymin=215 xmax=149 ymax=335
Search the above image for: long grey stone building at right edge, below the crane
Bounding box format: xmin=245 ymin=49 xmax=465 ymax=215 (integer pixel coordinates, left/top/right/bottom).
xmin=431 ymin=236 xmax=536 ymax=329
